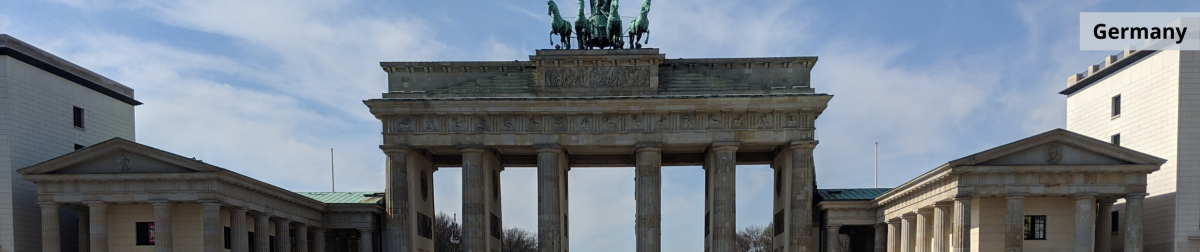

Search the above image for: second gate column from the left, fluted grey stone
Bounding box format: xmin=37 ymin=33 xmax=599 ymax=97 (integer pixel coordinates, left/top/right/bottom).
xmin=461 ymin=148 xmax=488 ymax=252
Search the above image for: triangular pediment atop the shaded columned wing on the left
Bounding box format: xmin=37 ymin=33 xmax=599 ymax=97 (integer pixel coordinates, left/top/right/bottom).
xmin=18 ymin=138 xmax=221 ymax=174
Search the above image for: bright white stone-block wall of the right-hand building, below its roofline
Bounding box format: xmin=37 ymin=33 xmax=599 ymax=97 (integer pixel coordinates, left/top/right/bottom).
xmin=1067 ymin=50 xmax=1200 ymax=251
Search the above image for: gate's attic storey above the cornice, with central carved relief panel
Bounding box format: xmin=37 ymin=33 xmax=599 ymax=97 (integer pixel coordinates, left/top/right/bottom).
xmin=380 ymin=49 xmax=817 ymax=98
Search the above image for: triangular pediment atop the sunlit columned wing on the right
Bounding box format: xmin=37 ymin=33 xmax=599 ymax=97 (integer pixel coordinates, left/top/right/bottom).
xmin=948 ymin=128 xmax=1166 ymax=167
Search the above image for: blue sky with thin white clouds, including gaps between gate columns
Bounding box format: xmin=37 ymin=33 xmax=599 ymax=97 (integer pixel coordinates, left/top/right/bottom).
xmin=0 ymin=0 xmax=1200 ymax=252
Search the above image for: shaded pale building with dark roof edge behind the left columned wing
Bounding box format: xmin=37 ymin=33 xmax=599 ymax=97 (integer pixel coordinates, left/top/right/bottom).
xmin=0 ymin=34 xmax=142 ymax=252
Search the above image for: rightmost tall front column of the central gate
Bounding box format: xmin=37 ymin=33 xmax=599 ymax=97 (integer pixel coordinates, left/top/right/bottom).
xmin=786 ymin=140 xmax=818 ymax=251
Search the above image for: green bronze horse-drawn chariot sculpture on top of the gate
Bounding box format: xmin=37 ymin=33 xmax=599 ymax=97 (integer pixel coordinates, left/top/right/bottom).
xmin=546 ymin=0 xmax=650 ymax=49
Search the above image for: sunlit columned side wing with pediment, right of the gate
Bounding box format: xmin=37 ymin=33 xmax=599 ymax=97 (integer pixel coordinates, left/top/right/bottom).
xmin=872 ymin=130 xmax=1165 ymax=251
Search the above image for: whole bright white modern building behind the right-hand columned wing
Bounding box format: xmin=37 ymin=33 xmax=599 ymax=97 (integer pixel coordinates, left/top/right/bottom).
xmin=1060 ymin=50 xmax=1200 ymax=251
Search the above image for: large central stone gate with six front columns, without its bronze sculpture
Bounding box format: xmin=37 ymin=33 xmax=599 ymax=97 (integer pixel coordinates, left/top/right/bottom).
xmin=364 ymin=49 xmax=833 ymax=252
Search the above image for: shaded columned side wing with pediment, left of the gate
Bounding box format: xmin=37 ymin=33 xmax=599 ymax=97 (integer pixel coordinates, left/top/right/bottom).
xmin=18 ymin=138 xmax=326 ymax=251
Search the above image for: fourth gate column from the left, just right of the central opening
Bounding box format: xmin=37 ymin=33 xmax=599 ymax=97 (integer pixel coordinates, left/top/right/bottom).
xmin=634 ymin=143 xmax=662 ymax=252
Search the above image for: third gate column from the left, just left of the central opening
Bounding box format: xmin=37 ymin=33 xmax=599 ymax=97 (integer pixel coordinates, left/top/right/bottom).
xmin=536 ymin=145 xmax=563 ymax=252
